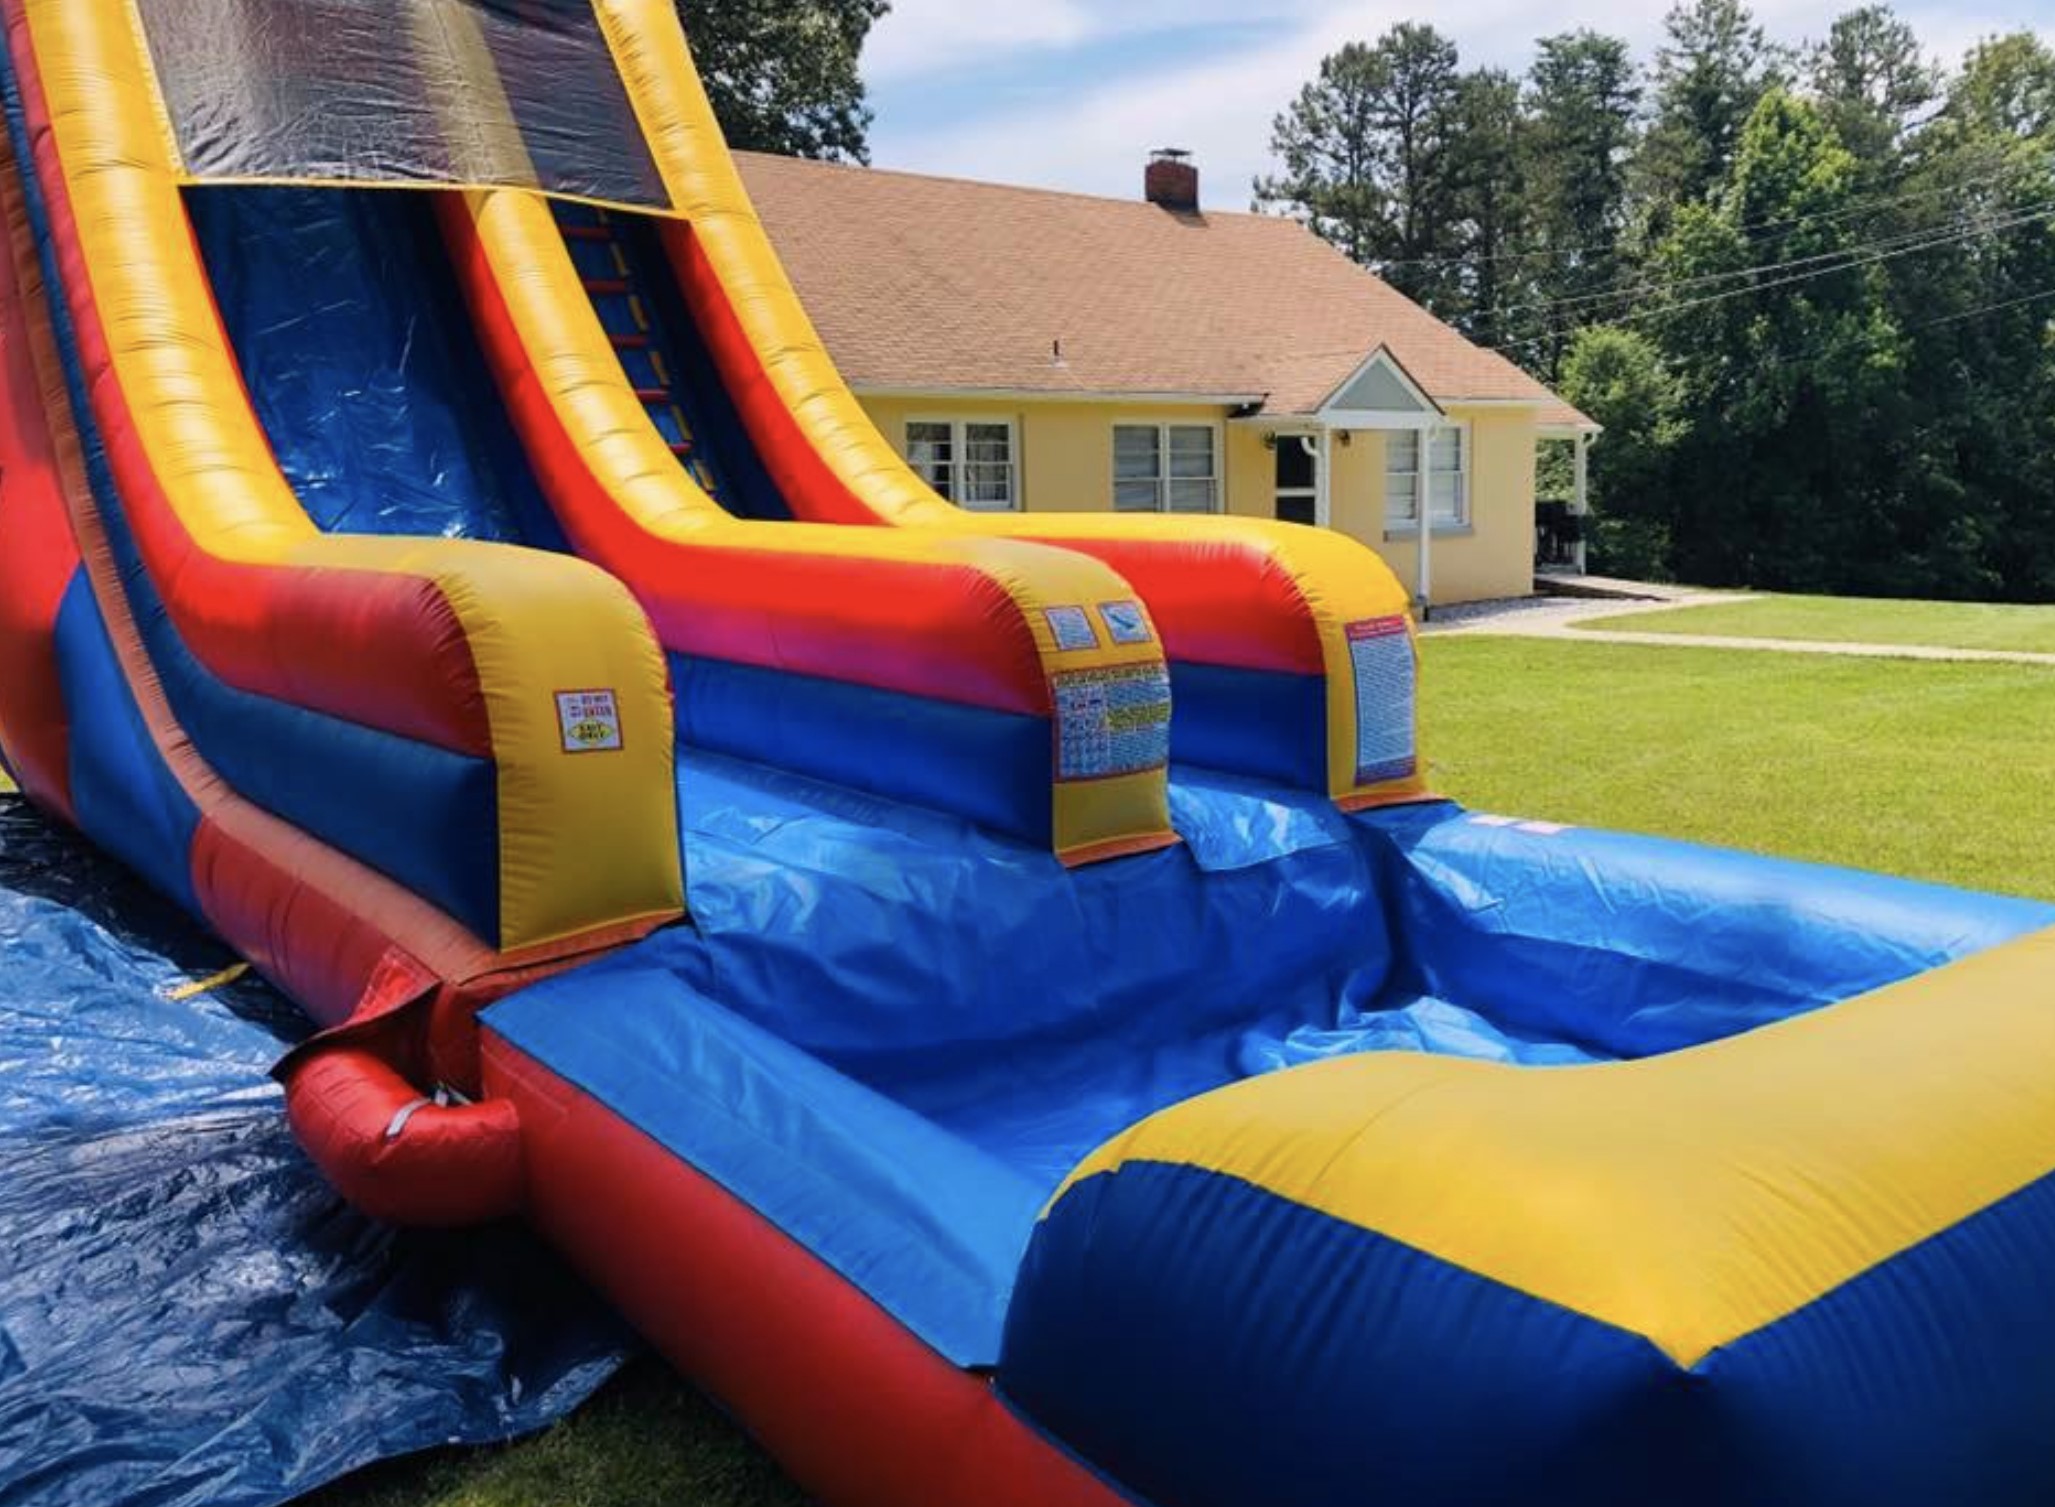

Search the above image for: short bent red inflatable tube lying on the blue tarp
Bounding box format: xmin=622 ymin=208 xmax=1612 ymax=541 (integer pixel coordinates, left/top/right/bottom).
xmin=286 ymin=1044 xmax=522 ymax=1229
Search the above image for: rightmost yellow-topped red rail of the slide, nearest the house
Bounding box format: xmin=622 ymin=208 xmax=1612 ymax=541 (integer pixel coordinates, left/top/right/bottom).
xmin=596 ymin=0 xmax=1426 ymax=806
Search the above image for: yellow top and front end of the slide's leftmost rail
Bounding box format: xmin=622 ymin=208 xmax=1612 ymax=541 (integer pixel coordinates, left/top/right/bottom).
xmin=27 ymin=0 xmax=684 ymax=952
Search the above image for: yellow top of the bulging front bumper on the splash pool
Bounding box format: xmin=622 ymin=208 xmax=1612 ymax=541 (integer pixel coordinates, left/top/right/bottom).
xmin=1056 ymin=931 xmax=2055 ymax=1367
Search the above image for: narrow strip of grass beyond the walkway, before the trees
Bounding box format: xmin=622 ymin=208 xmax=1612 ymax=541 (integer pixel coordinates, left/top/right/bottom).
xmin=1576 ymin=596 xmax=2055 ymax=654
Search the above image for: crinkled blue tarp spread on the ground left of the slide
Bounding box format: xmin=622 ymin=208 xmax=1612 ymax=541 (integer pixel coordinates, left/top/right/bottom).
xmin=0 ymin=798 xmax=631 ymax=1507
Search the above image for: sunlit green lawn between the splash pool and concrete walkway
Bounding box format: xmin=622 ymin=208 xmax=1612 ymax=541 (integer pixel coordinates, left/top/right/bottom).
xmin=1424 ymin=633 xmax=2055 ymax=900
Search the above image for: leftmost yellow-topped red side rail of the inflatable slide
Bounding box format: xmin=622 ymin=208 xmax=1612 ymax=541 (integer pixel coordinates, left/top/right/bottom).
xmin=8 ymin=0 xmax=682 ymax=954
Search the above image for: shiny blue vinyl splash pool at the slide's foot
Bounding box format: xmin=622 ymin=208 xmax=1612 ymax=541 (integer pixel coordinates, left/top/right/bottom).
xmin=487 ymin=752 xmax=2055 ymax=1365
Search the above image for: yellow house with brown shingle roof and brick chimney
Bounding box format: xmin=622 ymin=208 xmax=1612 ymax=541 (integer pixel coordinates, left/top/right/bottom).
xmin=740 ymin=152 xmax=1597 ymax=604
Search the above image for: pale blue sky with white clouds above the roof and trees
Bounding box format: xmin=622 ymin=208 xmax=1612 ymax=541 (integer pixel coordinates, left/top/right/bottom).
xmin=865 ymin=0 xmax=2055 ymax=210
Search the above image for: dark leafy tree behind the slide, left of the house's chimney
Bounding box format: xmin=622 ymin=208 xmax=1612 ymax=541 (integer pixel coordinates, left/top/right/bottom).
xmin=678 ymin=0 xmax=892 ymax=162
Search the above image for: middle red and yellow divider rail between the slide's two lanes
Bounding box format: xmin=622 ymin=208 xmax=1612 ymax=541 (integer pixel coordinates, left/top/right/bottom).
xmin=444 ymin=189 xmax=1175 ymax=863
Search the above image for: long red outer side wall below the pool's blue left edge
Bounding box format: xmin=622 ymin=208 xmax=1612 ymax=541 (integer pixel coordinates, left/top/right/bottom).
xmin=483 ymin=1030 xmax=1132 ymax=1507
